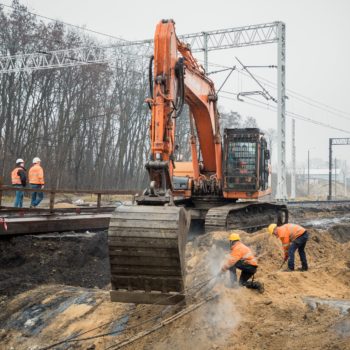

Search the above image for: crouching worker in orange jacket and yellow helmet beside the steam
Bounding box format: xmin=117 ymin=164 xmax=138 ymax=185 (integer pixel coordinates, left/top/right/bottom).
xmin=221 ymin=233 xmax=264 ymax=293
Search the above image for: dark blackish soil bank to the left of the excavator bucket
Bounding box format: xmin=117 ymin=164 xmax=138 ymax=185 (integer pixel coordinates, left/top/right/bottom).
xmin=0 ymin=232 xmax=110 ymax=295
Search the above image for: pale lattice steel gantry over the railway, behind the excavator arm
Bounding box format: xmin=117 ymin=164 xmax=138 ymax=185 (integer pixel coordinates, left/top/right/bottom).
xmin=0 ymin=22 xmax=287 ymax=200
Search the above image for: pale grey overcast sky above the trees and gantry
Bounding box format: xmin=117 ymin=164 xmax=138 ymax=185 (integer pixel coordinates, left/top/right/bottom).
xmin=14 ymin=0 xmax=350 ymax=168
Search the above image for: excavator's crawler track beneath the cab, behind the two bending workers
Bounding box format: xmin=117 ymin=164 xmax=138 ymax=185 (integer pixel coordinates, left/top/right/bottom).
xmin=205 ymin=202 xmax=288 ymax=232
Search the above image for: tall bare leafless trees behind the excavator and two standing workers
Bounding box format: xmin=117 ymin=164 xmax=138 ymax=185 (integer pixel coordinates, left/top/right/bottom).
xmin=0 ymin=0 xmax=268 ymax=189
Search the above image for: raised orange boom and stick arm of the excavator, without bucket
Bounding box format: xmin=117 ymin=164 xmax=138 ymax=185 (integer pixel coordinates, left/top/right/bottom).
xmin=139 ymin=20 xmax=222 ymax=204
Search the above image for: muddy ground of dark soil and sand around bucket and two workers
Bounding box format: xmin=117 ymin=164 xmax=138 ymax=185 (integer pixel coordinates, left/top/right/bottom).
xmin=0 ymin=204 xmax=350 ymax=350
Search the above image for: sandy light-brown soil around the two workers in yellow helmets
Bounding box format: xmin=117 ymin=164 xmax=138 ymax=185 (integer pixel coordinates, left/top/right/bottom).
xmin=152 ymin=229 xmax=350 ymax=350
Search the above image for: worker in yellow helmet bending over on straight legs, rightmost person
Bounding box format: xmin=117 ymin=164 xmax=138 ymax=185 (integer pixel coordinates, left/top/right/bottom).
xmin=268 ymin=224 xmax=309 ymax=271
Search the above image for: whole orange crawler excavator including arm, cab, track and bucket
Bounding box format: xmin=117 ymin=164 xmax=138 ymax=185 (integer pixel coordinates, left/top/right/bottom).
xmin=108 ymin=20 xmax=288 ymax=304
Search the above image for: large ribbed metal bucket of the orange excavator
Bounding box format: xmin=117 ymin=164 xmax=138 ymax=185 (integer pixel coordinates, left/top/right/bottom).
xmin=108 ymin=205 xmax=190 ymax=305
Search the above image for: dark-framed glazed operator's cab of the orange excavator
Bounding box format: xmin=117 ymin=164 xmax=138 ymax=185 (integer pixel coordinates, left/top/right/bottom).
xmin=223 ymin=128 xmax=270 ymax=198
